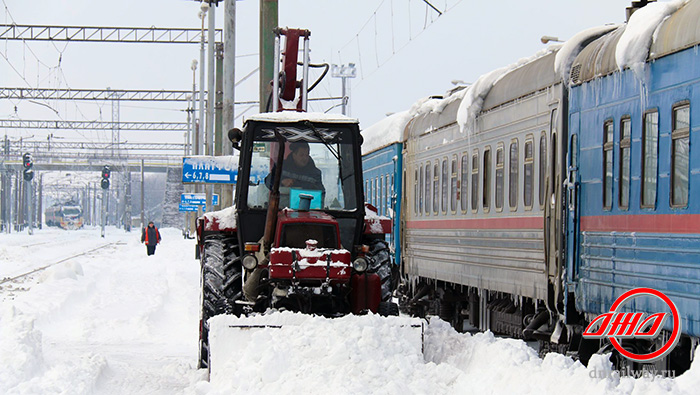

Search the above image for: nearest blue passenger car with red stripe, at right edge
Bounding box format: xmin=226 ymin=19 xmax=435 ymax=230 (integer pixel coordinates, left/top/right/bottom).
xmin=567 ymin=1 xmax=700 ymax=344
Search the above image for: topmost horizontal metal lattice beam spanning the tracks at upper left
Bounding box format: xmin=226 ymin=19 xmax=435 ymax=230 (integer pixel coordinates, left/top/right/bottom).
xmin=0 ymin=24 xmax=223 ymax=44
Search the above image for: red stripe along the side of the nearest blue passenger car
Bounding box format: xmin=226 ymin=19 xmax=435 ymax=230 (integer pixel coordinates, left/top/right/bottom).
xmin=581 ymin=214 xmax=700 ymax=233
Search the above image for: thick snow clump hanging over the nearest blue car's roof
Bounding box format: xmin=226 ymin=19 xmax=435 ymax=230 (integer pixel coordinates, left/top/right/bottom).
xmin=615 ymin=0 xmax=688 ymax=80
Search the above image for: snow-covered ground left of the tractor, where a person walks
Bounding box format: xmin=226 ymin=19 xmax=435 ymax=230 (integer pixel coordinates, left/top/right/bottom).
xmin=0 ymin=227 xmax=201 ymax=394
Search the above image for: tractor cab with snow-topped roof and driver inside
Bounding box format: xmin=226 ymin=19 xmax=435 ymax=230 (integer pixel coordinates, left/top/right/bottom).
xmin=232 ymin=113 xmax=365 ymax=255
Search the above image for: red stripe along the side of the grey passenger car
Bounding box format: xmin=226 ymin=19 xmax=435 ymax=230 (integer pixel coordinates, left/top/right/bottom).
xmin=406 ymin=217 xmax=544 ymax=230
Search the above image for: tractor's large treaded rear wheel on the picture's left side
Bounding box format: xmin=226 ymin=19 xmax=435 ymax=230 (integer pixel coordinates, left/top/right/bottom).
xmin=197 ymin=233 xmax=242 ymax=368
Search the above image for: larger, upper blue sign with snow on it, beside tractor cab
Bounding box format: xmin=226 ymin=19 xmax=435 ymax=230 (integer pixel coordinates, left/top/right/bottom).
xmin=182 ymin=156 xmax=238 ymax=184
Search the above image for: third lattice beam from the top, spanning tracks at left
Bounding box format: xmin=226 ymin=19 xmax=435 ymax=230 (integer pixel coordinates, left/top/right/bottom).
xmin=0 ymin=119 xmax=187 ymax=132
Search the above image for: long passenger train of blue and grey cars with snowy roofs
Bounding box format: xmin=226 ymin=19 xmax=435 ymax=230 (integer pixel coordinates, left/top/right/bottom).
xmin=362 ymin=0 xmax=700 ymax=373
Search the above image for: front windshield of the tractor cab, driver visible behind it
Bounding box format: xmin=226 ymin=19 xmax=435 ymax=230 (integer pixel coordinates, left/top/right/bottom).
xmin=248 ymin=127 xmax=357 ymax=210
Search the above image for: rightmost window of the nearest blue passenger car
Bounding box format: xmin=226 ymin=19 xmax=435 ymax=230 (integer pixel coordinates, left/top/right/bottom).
xmin=671 ymin=102 xmax=690 ymax=207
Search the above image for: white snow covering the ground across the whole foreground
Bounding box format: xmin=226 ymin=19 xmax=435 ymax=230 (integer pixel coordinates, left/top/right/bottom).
xmin=0 ymin=228 xmax=700 ymax=395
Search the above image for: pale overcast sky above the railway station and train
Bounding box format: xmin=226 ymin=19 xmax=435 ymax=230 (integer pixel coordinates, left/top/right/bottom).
xmin=0 ymin=0 xmax=631 ymax=142
